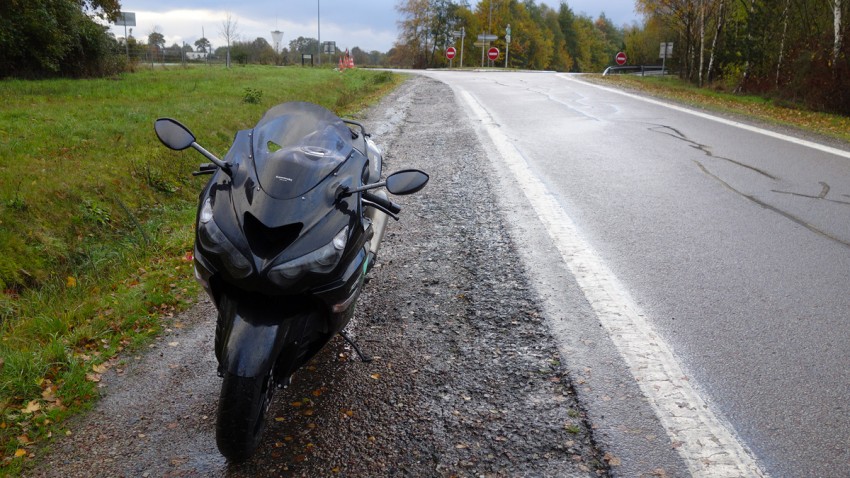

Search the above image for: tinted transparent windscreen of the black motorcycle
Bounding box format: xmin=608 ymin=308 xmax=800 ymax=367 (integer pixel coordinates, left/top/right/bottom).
xmin=253 ymin=103 xmax=353 ymax=199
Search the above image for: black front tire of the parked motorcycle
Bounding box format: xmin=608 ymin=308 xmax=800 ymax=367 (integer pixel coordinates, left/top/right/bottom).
xmin=215 ymin=372 xmax=275 ymax=461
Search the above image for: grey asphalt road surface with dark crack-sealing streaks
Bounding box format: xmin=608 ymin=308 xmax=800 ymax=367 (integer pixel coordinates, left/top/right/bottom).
xmin=416 ymin=72 xmax=850 ymax=476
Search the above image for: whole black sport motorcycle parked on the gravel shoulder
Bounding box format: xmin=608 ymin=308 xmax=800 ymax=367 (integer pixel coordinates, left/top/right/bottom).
xmin=154 ymin=102 xmax=429 ymax=461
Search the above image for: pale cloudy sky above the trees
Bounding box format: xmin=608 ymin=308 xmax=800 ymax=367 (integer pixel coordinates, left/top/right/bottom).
xmin=107 ymin=0 xmax=639 ymax=52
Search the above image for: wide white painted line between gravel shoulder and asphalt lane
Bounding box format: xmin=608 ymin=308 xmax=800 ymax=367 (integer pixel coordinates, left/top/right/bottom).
xmin=459 ymin=91 xmax=767 ymax=478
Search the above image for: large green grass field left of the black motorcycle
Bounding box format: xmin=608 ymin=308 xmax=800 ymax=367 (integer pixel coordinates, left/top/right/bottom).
xmin=0 ymin=67 xmax=401 ymax=474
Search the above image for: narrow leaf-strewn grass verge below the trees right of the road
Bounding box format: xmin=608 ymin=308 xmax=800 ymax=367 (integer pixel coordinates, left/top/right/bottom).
xmin=587 ymin=75 xmax=850 ymax=142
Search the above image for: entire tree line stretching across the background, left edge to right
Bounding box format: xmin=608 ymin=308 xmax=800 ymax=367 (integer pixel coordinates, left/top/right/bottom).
xmin=9 ymin=0 xmax=850 ymax=114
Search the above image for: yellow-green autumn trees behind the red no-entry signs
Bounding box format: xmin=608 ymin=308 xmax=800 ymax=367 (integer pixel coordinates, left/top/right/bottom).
xmin=388 ymin=0 xmax=625 ymax=72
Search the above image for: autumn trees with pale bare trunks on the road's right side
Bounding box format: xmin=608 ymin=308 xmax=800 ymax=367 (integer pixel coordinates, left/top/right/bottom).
xmin=625 ymin=0 xmax=850 ymax=114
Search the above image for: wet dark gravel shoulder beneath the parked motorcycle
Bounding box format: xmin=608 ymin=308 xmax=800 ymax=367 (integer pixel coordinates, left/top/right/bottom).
xmin=27 ymin=77 xmax=609 ymax=477
